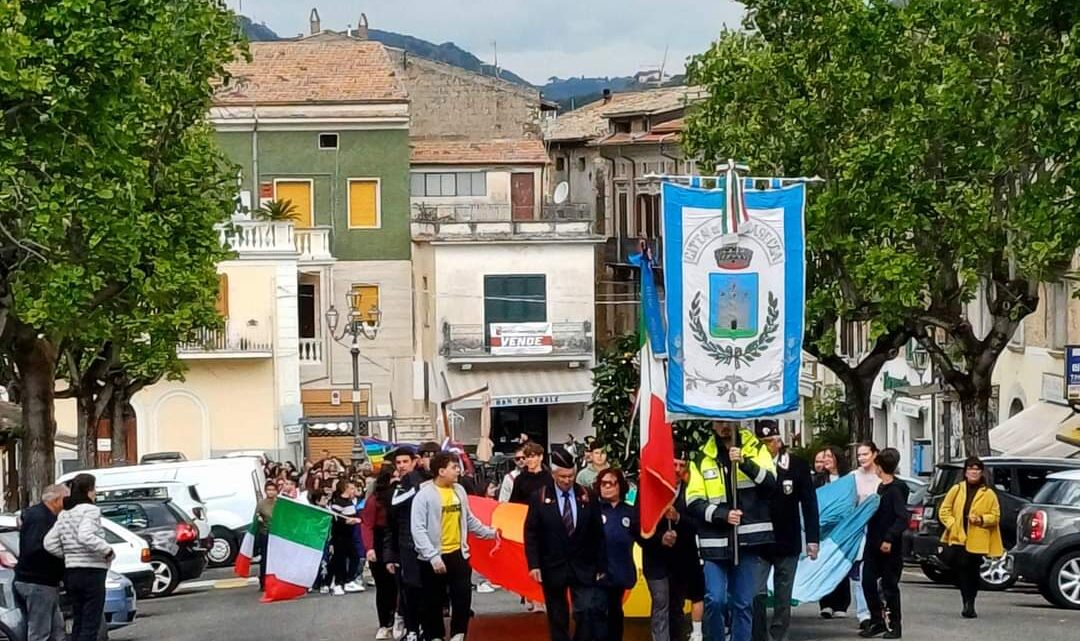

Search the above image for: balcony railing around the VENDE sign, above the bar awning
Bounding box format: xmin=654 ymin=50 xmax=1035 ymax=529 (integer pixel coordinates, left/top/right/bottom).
xmin=442 ymin=321 xmax=593 ymax=363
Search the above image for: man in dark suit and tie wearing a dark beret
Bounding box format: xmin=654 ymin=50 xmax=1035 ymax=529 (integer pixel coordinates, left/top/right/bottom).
xmin=525 ymin=449 xmax=606 ymax=641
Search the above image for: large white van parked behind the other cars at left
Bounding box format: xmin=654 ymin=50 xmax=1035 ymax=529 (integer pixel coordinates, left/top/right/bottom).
xmin=57 ymin=458 xmax=266 ymax=565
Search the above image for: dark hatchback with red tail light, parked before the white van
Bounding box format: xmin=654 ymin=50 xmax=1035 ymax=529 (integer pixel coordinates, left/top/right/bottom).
xmin=97 ymin=499 xmax=210 ymax=597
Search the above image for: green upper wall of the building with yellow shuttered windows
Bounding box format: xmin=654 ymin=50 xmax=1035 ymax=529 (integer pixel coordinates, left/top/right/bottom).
xmin=218 ymin=126 xmax=409 ymax=260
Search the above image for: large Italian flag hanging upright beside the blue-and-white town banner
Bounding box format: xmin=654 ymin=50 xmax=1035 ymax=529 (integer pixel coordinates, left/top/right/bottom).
xmin=637 ymin=331 xmax=676 ymax=538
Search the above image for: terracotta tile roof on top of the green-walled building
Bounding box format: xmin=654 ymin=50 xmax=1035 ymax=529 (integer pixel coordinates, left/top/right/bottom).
xmin=214 ymin=40 xmax=408 ymax=106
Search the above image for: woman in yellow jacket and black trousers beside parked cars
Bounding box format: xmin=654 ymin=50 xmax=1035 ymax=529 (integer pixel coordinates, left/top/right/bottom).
xmin=937 ymin=456 xmax=1005 ymax=618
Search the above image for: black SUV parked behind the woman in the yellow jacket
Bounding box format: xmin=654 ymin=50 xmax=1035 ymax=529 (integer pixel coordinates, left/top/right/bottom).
xmin=913 ymin=456 xmax=1080 ymax=590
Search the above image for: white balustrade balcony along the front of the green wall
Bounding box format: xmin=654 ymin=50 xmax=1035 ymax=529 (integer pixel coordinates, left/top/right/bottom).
xmin=218 ymin=220 xmax=335 ymax=264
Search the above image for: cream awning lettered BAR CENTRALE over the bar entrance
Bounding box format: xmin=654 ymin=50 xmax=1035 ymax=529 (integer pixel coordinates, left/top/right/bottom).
xmin=446 ymin=367 xmax=593 ymax=409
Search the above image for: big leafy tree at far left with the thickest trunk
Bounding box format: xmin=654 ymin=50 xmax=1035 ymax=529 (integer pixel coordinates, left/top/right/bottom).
xmin=0 ymin=0 xmax=240 ymax=500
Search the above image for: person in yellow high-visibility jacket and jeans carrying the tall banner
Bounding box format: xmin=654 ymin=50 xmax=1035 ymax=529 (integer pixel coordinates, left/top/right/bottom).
xmin=686 ymin=421 xmax=777 ymax=641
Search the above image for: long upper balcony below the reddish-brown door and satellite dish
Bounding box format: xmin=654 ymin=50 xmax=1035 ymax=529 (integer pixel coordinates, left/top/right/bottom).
xmin=411 ymin=202 xmax=598 ymax=241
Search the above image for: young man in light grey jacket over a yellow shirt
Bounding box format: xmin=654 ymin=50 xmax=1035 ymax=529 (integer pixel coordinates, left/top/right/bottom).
xmin=411 ymin=452 xmax=496 ymax=641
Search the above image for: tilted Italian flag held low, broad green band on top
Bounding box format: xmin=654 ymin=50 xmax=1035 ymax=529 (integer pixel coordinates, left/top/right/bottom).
xmin=262 ymin=496 xmax=333 ymax=603
